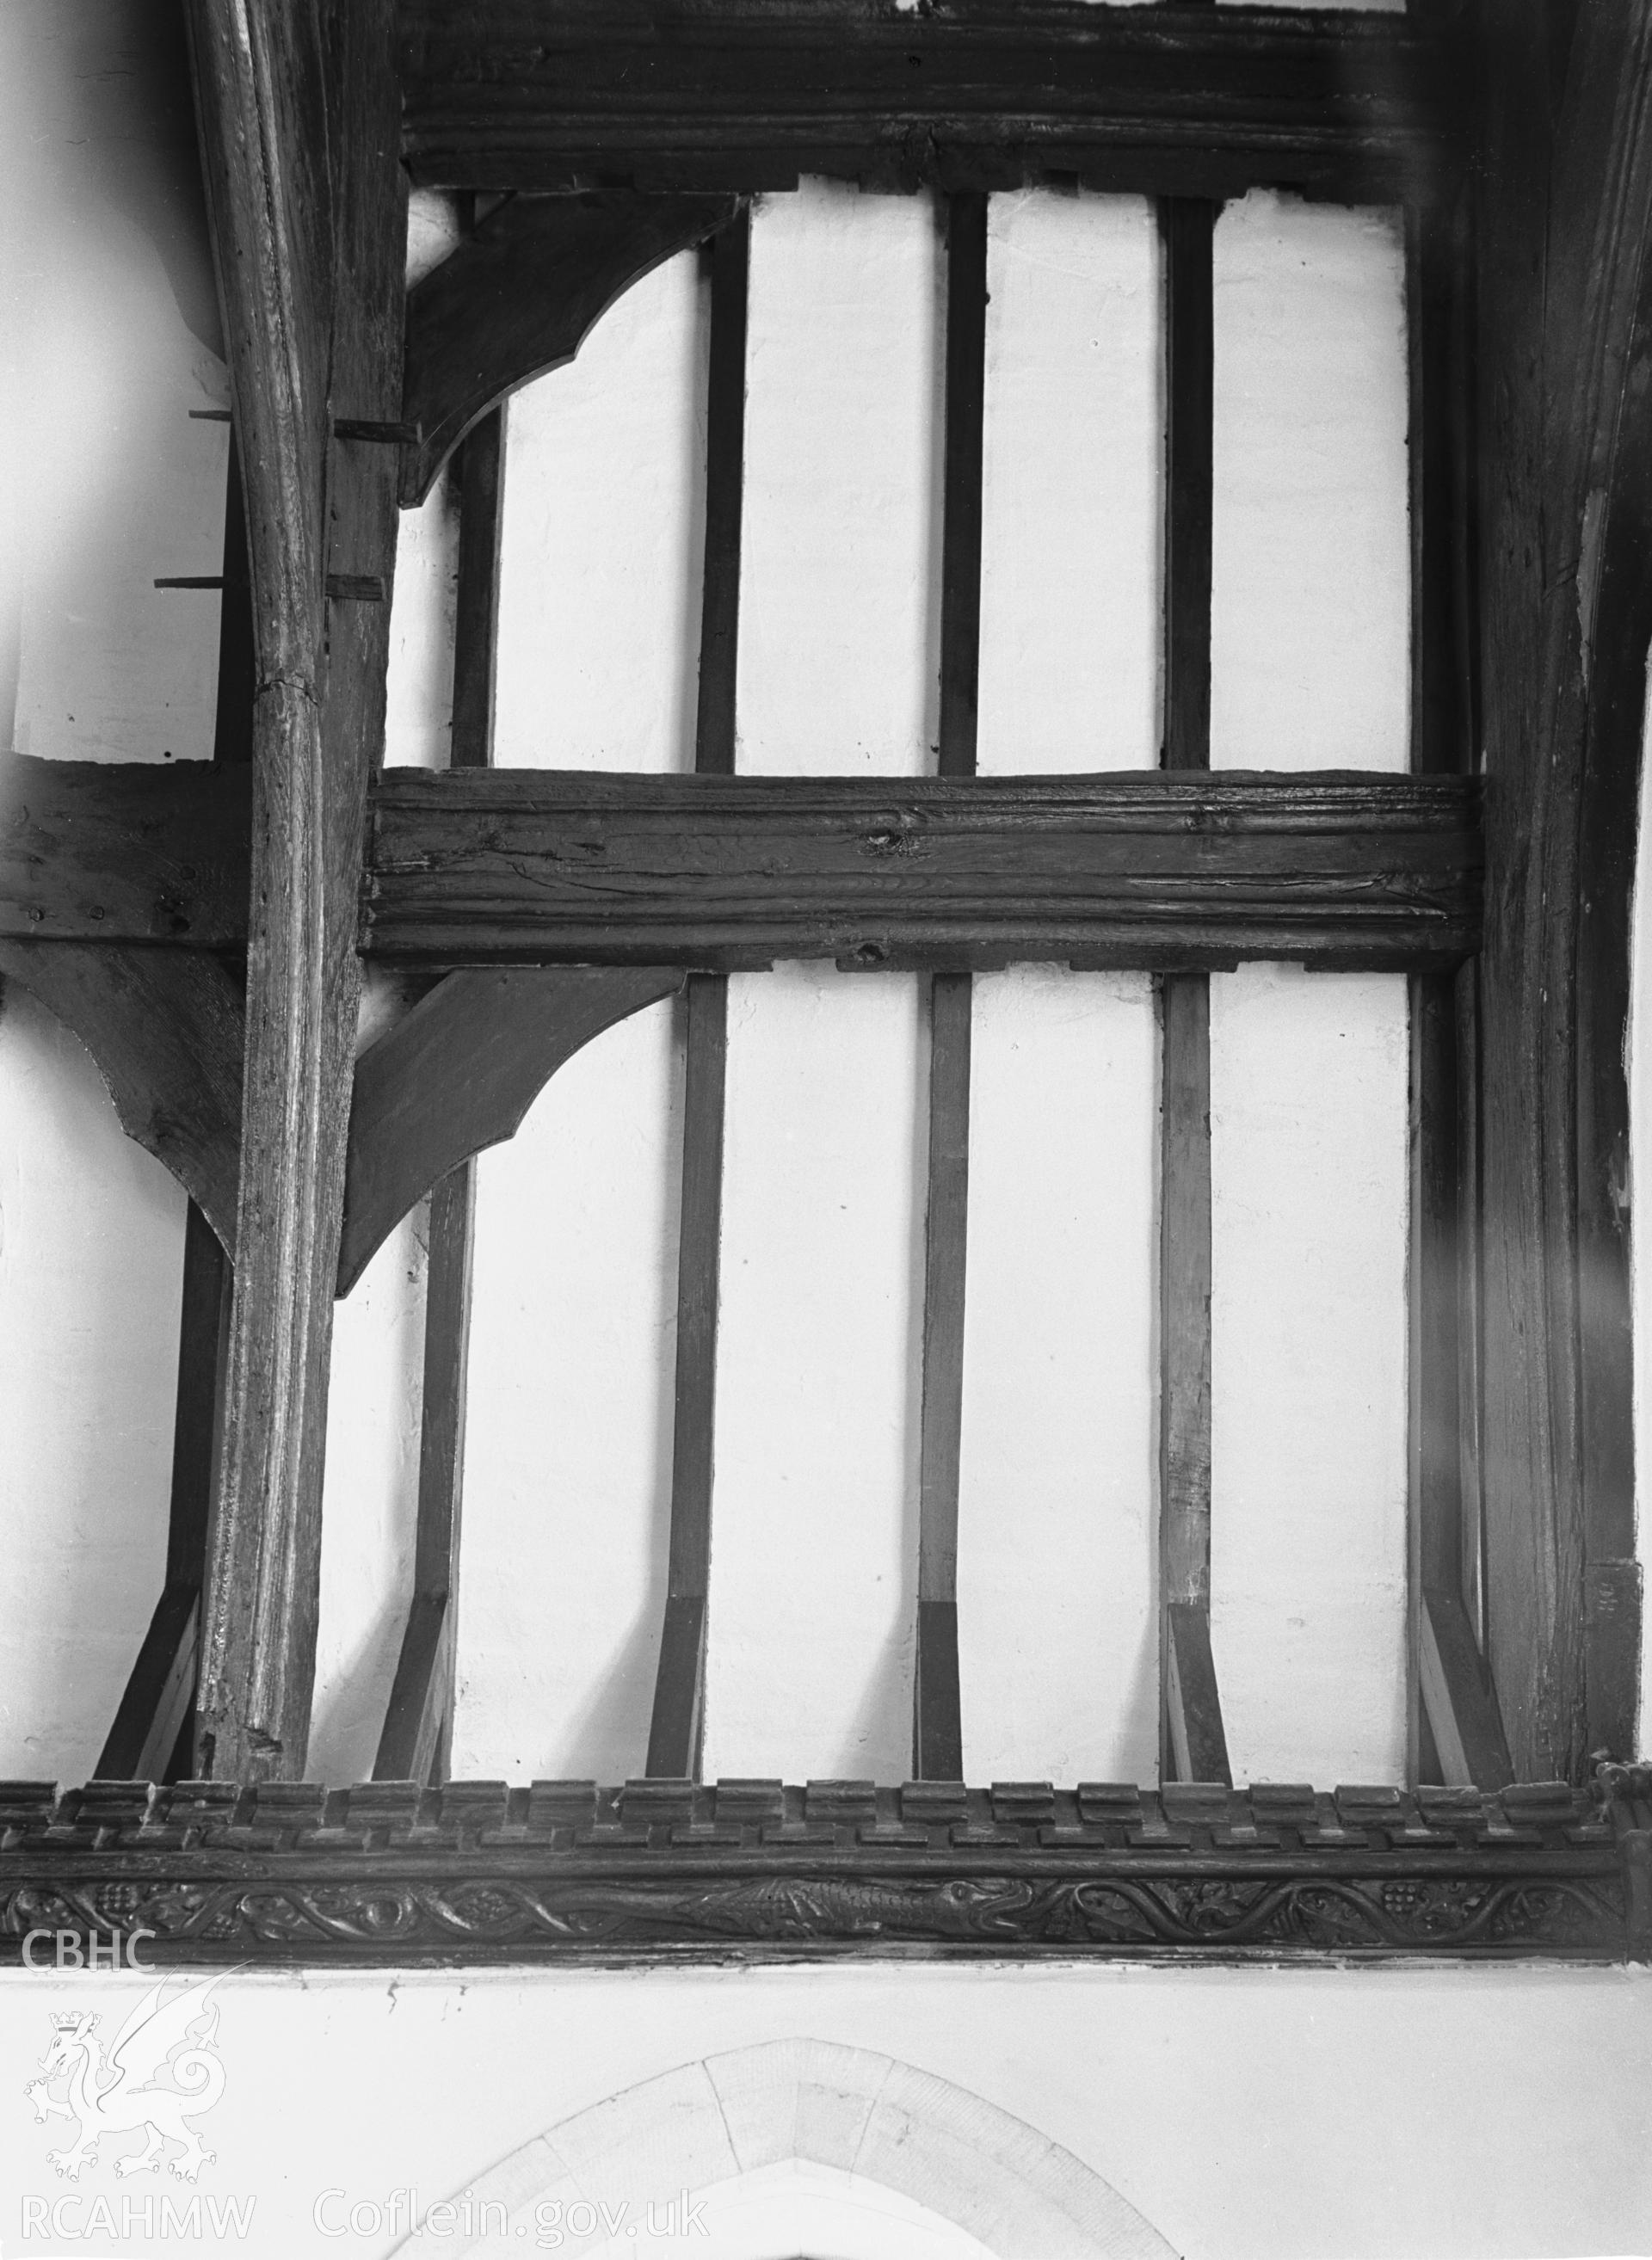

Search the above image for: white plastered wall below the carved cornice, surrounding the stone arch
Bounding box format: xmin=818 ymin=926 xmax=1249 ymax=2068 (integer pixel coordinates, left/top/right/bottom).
xmin=0 ymin=1964 xmax=1652 ymax=2260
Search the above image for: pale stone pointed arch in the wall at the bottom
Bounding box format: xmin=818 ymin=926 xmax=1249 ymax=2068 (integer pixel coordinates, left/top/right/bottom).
xmin=398 ymin=2039 xmax=1173 ymax=2260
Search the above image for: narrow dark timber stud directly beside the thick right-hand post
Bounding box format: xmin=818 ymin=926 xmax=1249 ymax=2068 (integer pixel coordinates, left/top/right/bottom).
xmin=1406 ymin=189 xmax=1512 ymax=1790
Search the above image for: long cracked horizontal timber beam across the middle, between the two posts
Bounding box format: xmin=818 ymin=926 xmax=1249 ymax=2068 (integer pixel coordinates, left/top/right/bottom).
xmin=364 ymin=771 xmax=1480 ymax=970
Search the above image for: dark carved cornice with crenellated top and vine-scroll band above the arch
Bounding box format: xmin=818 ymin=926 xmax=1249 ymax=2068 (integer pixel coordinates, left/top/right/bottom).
xmin=0 ymin=1767 xmax=1652 ymax=1966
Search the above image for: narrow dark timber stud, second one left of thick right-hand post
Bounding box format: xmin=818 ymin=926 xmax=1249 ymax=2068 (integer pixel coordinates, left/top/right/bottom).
xmin=1159 ymin=197 xmax=1231 ymax=1783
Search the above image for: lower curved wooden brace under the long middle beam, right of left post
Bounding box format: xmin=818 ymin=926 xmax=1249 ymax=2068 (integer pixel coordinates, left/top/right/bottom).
xmin=339 ymin=965 xmax=687 ymax=1295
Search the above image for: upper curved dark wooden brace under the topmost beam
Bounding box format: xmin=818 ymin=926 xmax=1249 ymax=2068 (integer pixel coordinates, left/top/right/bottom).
xmin=403 ymin=190 xmax=742 ymax=508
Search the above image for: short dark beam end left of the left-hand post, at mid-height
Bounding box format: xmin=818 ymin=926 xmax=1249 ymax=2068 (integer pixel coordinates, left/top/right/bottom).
xmin=0 ymin=753 xmax=251 ymax=949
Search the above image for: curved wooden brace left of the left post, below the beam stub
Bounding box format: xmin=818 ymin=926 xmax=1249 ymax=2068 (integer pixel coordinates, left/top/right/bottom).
xmin=0 ymin=940 xmax=246 ymax=1259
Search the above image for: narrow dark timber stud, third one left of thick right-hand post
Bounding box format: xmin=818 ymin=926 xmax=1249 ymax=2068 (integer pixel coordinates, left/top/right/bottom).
xmin=913 ymin=192 xmax=988 ymax=1781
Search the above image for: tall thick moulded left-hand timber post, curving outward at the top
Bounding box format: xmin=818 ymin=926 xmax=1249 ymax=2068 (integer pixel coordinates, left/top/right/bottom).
xmin=188 ymin=0 xmax=404 ymax=1781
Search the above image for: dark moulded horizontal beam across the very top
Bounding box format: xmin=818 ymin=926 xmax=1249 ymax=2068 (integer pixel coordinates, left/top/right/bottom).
xmin=400 ymin=0 xmax=1451 ymax=201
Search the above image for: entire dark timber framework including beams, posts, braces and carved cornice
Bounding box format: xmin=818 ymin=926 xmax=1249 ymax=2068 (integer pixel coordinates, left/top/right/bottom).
xmin=0 ymin=0 xmax=1652 ymax=1960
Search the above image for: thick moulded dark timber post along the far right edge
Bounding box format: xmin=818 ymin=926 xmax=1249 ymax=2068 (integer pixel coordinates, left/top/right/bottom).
xmin=1476 ymin=4 xmax=1652 ymax=1778
